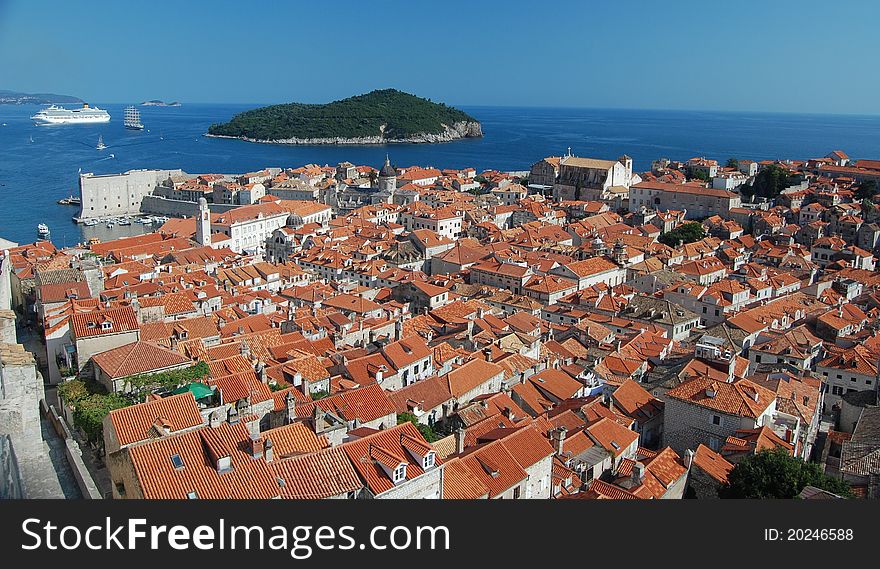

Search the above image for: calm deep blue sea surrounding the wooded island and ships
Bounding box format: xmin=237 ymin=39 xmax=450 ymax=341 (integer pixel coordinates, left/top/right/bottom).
xmin=0 ymin=104 xmax=880 ymax=245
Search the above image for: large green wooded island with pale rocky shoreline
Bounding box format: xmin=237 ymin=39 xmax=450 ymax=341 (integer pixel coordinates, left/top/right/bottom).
xmin=206 ymin=89 xmax=483 ymax=144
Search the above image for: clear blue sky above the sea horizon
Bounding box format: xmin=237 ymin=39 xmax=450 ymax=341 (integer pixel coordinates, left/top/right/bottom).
xmin=0 ymin=0 xmax=880 ymax=114
